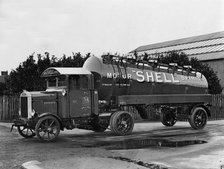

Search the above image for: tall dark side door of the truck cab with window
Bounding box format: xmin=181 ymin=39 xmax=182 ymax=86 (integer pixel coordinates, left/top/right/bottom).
xmin=69 ymin=75 xmax=92 ymax=118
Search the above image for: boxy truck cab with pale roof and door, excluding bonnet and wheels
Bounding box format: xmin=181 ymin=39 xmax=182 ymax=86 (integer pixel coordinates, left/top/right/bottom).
xmin=42 ymin=68 xmax=97 ymax=118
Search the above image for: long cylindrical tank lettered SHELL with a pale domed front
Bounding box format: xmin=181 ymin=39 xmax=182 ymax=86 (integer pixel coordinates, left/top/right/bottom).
xmin=83 ymin=56 xmax=208 ymax=100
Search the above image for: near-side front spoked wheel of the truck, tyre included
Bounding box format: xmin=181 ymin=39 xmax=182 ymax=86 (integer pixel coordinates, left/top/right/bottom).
xmin=35 ymin=116 xmax=60 ymax=141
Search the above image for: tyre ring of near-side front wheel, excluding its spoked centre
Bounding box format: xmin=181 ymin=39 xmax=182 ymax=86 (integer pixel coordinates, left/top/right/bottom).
xmin=35 ymin=116 xmax=60 ymax=142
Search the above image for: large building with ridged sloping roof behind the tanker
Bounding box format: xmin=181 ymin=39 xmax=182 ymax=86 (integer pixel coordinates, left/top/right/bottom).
xmin=130 ymin=31 xmax=224 ymax=88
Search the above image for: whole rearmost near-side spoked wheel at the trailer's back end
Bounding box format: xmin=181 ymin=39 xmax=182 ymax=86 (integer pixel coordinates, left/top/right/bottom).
xmin=189 ymin=107 xmax=208 ymax=129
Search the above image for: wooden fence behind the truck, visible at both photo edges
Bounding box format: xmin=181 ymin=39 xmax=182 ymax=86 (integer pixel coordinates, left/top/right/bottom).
xmin=0 ymin=94 xmax=224 ymax=121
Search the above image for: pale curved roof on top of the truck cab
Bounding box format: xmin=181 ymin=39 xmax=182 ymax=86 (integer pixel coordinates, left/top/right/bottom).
xmin=41 ymin=67 xmax=91 ymax=77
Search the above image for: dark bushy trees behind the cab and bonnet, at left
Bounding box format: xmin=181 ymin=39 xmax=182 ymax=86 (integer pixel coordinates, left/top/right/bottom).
xmin=5 ymin=52 xmax=90 ymax=94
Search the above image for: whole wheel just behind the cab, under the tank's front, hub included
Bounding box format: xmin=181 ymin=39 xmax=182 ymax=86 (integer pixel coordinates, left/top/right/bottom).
xmin=110 ymin=111 xmax=134 ymax=135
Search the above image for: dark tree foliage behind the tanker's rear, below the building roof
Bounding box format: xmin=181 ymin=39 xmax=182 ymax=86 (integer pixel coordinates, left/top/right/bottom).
xmin=159 ymin=51 xmax=222 ymax=94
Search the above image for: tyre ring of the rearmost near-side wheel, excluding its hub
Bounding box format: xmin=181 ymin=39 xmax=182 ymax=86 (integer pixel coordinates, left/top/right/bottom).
xmin=189 ymin=107 xmax=208 ymax=130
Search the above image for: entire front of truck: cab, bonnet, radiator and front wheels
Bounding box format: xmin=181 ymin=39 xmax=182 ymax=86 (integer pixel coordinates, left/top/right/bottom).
xmin=14 ymin=67 xmax=108 ymax=141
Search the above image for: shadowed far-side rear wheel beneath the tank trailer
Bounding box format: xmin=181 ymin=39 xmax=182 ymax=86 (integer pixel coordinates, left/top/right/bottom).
xmin=160 ymin=112 xmax=177 ymax=126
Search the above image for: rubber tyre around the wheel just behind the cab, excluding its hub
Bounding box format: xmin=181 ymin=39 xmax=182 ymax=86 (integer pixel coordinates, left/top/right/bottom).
xmin=110 ymin=111 xmax=134 ymax=136
